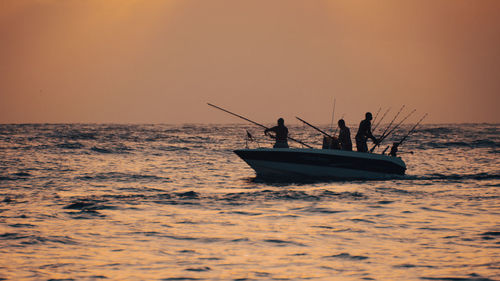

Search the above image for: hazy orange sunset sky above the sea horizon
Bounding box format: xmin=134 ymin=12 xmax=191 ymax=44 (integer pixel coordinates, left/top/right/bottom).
xmin=0 ymin=0 xmax=500 ymax=124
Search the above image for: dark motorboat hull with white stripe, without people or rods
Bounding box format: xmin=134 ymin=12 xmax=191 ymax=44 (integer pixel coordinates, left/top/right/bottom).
xmin=234 ymin=148 xmax=406 ymax=180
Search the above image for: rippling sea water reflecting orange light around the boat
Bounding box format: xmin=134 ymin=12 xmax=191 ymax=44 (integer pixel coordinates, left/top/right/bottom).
xmin=0 ymin=124 xmax=500 ymax=281
